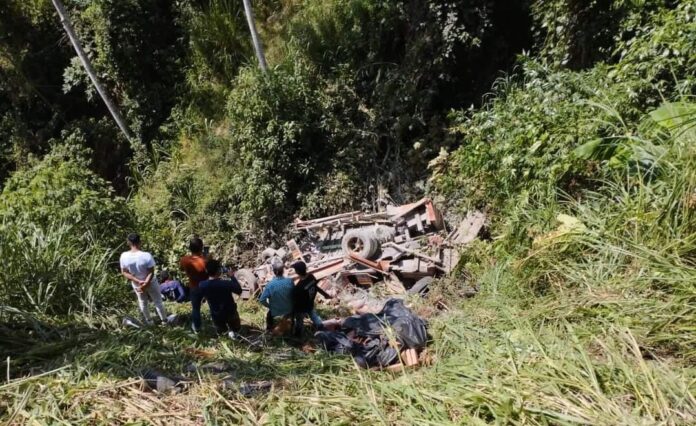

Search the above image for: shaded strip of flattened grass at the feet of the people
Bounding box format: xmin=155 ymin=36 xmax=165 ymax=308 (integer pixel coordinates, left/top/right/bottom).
xmin=0 ymin=313 xmax=346 ymax=388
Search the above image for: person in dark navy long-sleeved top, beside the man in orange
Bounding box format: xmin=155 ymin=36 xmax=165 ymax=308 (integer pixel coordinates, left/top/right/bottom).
xmin=198 ymin=259 xmax=242 ymax=338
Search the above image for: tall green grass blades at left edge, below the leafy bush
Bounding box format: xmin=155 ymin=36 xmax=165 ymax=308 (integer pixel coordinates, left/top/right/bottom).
xmin=0 ymin=220 xmax=125 ymax=315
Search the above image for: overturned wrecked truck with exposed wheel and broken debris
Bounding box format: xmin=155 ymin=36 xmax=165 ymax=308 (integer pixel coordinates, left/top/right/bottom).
xmin=235 ymin=198 xmax=485 ymax=299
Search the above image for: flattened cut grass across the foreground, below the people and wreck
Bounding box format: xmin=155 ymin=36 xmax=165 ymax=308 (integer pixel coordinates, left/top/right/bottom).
xmin=0 ymin=272 xmax=696 ymax=424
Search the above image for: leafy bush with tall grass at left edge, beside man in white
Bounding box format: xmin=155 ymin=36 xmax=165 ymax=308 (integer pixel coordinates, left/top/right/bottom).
xmin=0 ymin=145 xmax=133 ymax=314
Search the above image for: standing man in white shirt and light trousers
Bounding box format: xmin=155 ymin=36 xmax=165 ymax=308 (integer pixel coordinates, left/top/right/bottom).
xmin=120 ymin=234 xmax=167 ymax=324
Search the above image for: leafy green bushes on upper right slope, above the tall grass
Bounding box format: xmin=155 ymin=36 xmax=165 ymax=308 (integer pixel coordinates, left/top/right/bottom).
xmin=433 ymin=4 xmax=696 ymax=216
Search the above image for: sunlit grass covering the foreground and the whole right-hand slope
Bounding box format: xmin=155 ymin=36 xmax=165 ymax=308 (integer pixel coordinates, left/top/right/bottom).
xmin=0 ymin=101 xmax=696 ymax=425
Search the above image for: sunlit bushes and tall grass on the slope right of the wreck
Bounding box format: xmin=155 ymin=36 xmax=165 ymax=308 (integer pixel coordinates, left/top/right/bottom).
xmin=431 ymin=3 xmax=696 ymax=363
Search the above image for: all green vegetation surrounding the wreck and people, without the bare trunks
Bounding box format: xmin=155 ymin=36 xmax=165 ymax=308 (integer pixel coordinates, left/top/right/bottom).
xmin=0 ymin=0 xmax=696 ymax=424
